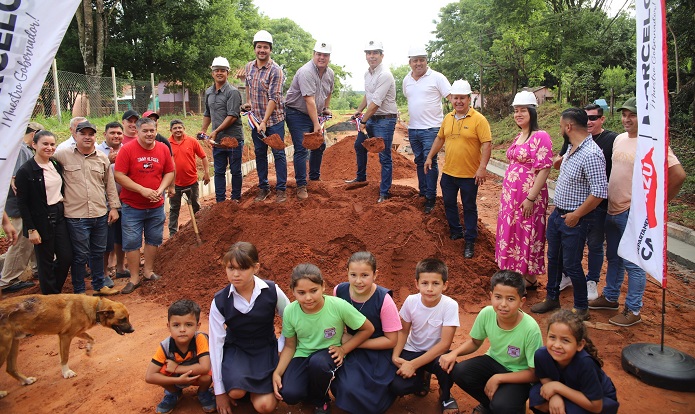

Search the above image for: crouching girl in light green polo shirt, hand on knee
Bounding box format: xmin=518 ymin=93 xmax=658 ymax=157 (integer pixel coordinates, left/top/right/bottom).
xmin=273 ymin=263 xmax=374 ymax=414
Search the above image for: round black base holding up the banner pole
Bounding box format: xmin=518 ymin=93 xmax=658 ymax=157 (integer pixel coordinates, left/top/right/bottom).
xmin=621 ymin=343 xmax=695 ymax=392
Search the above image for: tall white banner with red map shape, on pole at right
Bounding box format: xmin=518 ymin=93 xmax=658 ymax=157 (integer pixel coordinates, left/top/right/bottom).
xmin=618 ymin=0 xmax=668 ymax=288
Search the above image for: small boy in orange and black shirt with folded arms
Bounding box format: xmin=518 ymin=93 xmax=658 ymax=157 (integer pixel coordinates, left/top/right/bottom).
xmin=145 ymin=299 xmax=215 ymax=414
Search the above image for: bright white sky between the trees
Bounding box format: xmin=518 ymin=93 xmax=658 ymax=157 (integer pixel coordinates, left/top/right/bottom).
xmin=254 ymin=0 xmax=454 ymax=90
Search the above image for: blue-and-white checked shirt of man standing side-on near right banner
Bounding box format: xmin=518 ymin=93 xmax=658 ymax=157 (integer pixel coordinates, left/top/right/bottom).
xmin=555 ymin=135 xmax=608 ymax=211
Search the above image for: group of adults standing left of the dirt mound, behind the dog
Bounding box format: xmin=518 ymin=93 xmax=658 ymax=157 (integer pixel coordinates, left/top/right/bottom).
xmin=0 ymin=110 xmax=210 ymax=296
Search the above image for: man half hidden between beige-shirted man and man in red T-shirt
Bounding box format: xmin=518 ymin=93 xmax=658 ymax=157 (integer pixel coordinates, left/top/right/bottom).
xmin=97 ymin=122 xmax=130 ymax=287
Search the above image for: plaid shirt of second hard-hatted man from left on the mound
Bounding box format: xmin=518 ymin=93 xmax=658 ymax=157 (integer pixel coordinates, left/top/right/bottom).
xmin=246 ymin=59 xmax=285 ymax=126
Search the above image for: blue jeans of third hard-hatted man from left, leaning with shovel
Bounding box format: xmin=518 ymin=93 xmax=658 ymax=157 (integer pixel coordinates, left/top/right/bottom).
xmin=285 ymin=108 xmax=326 ymax=187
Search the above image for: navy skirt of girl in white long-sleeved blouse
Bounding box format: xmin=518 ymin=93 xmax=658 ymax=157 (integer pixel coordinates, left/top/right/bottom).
xmin=222 ymin=340 xmax=279 ymax=394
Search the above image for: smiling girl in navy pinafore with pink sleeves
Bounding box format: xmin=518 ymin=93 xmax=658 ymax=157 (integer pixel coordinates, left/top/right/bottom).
xmin=331 ymin=252 xmax=402 ymax=414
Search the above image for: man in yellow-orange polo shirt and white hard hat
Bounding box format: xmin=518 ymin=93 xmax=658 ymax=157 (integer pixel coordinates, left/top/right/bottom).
xmin=424 ymin=80 xmax=492 ymax=259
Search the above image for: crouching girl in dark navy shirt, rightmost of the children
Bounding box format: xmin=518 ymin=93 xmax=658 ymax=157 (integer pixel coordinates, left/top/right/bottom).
xmin=529 ymin=310 xmax=620 ymax=414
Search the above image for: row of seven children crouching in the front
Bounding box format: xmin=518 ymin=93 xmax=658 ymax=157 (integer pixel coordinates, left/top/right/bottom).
xmin=146 ymin=242 xmax=618 ymax=414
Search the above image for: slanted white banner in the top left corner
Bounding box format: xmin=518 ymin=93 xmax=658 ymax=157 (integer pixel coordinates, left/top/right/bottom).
xmin=0 ymin=0 xmax=80 ymax=217
